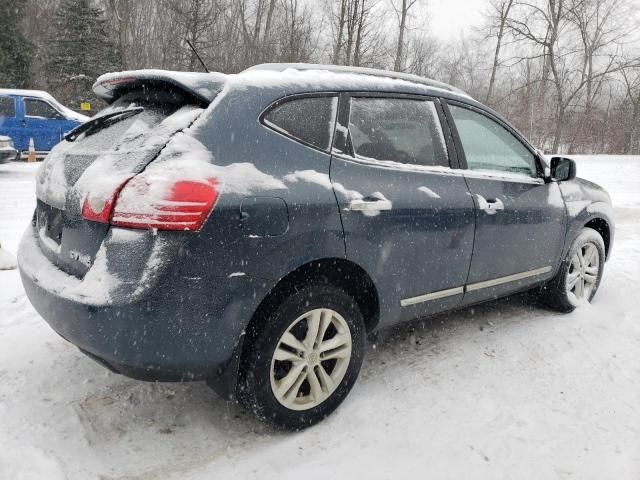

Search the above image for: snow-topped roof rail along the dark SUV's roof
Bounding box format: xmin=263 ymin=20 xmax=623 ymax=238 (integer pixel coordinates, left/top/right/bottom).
xmin=245 ymin=63 xmax=469 ymax=97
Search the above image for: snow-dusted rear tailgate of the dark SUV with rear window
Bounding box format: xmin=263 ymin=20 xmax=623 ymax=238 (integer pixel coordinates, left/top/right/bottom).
xmin=34 ymin=72 xmax=226 ymax=278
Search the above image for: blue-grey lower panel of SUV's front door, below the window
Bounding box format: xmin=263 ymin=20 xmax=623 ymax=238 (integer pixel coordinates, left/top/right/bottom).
xmin=464 ymin=175 xmax=566 ymax=303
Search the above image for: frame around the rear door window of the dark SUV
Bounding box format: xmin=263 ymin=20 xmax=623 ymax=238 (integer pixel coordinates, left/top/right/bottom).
xmin=332 ymin=91 xmax=461 ymax=173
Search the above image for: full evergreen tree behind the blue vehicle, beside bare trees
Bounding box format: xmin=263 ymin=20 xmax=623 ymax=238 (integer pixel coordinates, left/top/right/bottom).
xmin=47 ymin=0 xmax=118 ymax=109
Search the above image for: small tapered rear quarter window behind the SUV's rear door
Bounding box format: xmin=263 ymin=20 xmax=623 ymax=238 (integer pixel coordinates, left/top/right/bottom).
xmin=263 ymin=97 xmax=338 ymax=151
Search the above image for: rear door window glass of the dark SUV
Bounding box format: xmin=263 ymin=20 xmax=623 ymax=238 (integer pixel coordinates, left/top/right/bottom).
xmin=349 ymin=98 xmax=449 ymax=167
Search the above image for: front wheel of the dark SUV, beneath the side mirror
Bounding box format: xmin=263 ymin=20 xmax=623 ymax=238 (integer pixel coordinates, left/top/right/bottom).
xmin=541 ymin=228 xmax=606 ymax=312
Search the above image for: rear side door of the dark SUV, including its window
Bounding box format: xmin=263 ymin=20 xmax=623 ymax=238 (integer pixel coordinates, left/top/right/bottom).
xmin=331 ymin=94 xmax=474 ymax=325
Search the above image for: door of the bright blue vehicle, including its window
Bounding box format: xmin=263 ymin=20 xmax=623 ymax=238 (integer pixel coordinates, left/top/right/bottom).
xmin=24 ymin=97 xmax=65 ymax=151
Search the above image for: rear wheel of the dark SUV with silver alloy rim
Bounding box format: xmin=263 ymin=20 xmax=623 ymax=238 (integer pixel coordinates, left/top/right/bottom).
xmin=238 ymin=285 xmax=365 ymax=430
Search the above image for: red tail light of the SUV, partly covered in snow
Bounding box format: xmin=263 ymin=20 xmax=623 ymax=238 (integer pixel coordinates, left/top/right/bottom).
xmin=82 ymin=173 xmax=218 ymax=231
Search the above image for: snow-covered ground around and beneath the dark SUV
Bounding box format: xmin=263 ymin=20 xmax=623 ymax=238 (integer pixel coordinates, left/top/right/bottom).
xmin=0 ymin=157 xmax=640 ymax=480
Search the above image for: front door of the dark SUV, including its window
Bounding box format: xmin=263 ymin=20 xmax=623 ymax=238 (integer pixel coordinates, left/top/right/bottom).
xmin=448 ymin=102 xmax=566 ymax=303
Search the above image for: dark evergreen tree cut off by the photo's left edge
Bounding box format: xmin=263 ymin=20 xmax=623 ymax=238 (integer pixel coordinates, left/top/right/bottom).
xmin=0 ymin=0 xmax=32 ymax=88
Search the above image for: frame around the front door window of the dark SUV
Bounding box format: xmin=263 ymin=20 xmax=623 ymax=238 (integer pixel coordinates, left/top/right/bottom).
xmin=442 ymin=99 xmax=544 ymax=183
